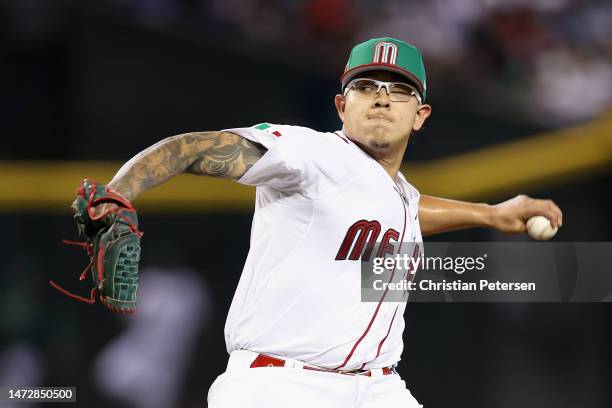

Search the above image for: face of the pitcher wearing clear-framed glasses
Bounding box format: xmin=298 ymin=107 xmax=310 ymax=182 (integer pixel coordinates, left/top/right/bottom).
xmin=335 ymin=71 xmax=431 ymax=155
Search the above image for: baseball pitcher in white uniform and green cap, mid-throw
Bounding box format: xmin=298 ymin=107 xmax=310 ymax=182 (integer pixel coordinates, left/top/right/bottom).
xmin=88 ymin=38 xmax=562 ymax=408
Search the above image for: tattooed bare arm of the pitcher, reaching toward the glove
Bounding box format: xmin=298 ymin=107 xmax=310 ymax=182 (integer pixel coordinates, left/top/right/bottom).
xmin=109 ymin=132 xmax=265 ymax=200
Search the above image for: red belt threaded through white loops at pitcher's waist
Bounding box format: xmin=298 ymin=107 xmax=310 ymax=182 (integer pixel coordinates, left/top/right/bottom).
xmin=228 ymin=350 xmax=397 ymax=377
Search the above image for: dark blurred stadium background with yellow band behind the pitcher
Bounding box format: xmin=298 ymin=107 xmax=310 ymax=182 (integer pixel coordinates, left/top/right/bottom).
xmin=0 ymin=0 xmax=612 ymax=408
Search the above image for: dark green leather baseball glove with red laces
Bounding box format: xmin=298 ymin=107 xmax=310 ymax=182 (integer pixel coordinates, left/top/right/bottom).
xmin=49 ymin=179 xmax=143 ymax=313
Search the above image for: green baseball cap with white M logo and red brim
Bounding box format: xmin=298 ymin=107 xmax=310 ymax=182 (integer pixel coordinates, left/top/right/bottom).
xmin=340 ymin=37 xmax=427 ymax=100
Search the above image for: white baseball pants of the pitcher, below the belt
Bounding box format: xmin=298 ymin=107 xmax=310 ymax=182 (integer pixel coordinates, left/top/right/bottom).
xmin=208 ymin=350 xmax=422 ymax=408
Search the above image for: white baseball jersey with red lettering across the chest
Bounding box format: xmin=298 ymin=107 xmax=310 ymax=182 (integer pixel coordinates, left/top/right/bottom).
xmin=225 ymin=123 xmax=422 ymax=370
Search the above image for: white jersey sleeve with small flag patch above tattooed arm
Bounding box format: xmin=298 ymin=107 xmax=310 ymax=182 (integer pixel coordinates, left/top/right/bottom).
xmin=223 ymin=123 xmax=338 ymax=195
